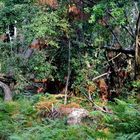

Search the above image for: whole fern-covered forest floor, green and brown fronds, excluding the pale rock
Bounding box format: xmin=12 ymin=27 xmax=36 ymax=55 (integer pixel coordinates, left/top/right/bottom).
xmin=0 ymin=85 xmax=140 ymax=140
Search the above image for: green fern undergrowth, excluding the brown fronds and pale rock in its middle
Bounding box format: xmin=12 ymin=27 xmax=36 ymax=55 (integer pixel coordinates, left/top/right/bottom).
xmin=0 ymin=95 xmax=140 ymax=140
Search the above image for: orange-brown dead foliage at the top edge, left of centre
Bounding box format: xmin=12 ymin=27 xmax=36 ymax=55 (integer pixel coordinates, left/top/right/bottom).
xmin=38 ymin=0 xmax=58 ymax=9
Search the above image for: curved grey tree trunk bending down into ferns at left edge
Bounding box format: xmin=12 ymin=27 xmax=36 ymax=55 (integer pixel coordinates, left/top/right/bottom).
xmin=0 ymin=81 xmax=12 ymax=101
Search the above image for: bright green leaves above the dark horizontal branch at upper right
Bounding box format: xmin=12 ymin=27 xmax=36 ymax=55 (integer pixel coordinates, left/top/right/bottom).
xmin=89 ymin=0 xmax=134 ymax=46
